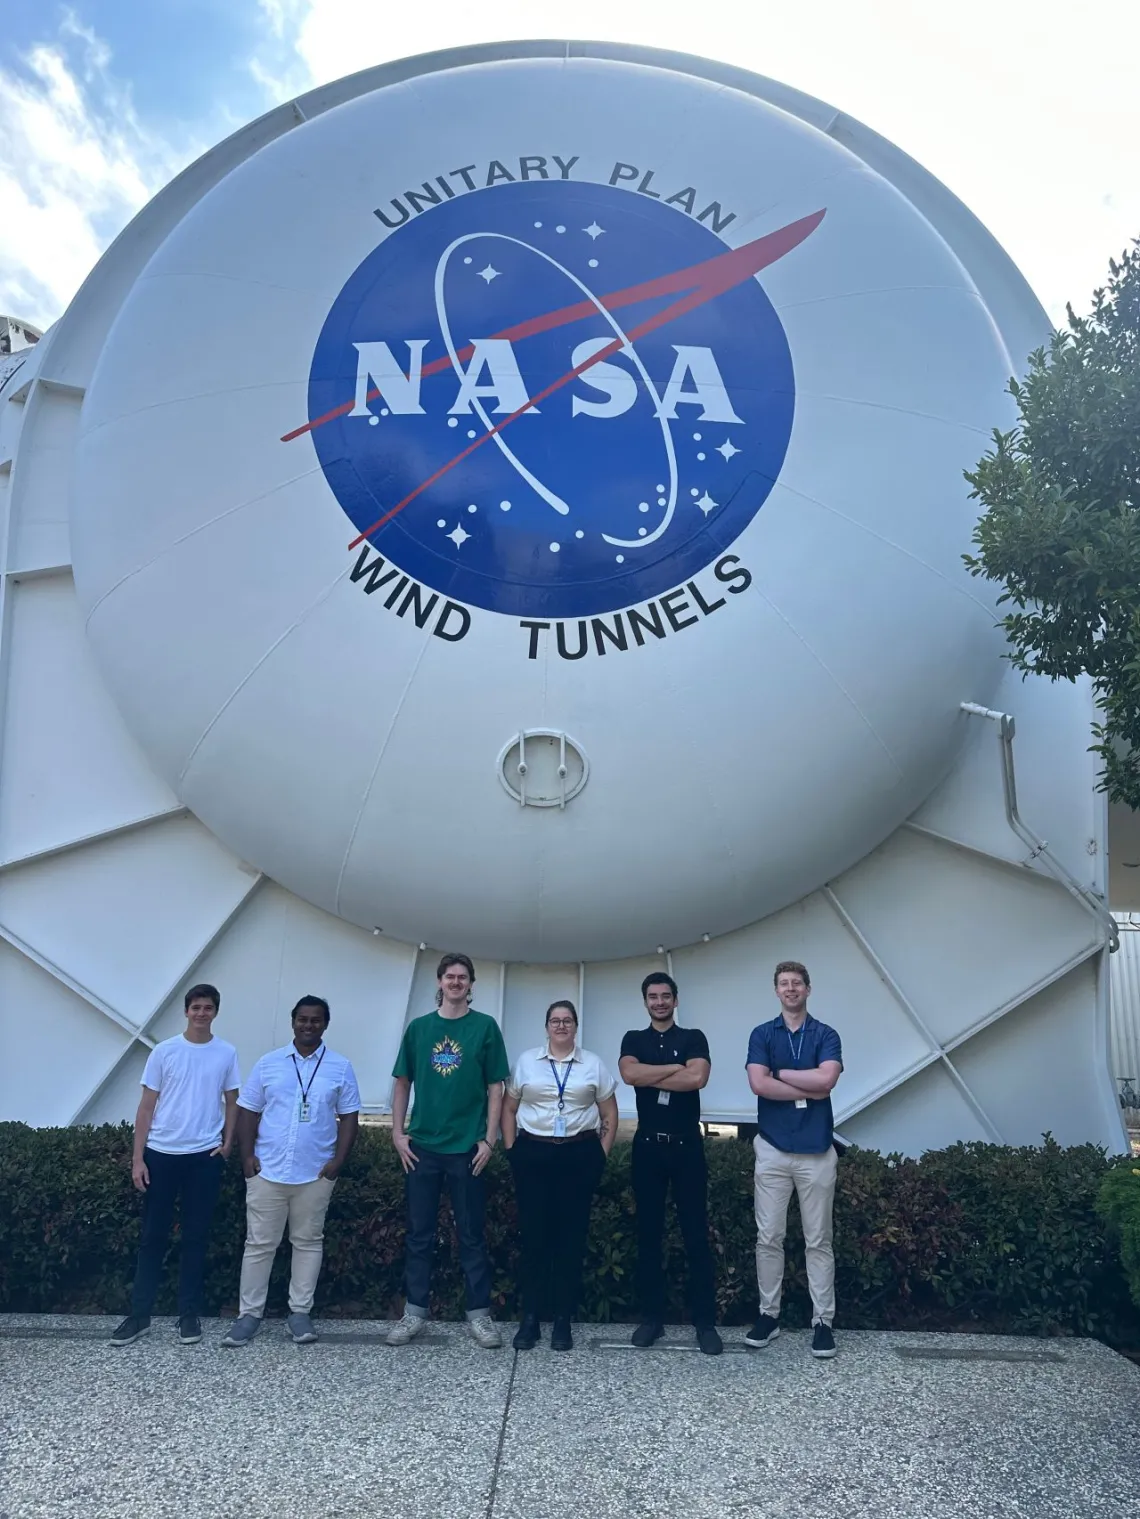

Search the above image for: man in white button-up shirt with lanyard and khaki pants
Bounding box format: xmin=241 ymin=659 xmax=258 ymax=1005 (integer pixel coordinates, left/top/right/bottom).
xmin=222 ymin=996 xmax=360 ymax=1346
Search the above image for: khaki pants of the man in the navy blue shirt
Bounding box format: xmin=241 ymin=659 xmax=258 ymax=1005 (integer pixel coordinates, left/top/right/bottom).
xmin=752 ymin=1135 xmax=838 ymax=1325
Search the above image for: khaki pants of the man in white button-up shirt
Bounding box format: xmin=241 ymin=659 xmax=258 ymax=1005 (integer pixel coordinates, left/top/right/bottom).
xmin=239 ymin=1176 xmax=336 ymax=1318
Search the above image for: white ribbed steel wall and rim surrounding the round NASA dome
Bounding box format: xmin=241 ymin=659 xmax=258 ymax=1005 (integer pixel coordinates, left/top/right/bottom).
xmin=0 ymin=44 xmax=1140 ymax=1151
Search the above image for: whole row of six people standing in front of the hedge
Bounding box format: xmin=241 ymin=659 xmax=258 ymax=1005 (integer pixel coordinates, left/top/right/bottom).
xmin=112 ymin=954 xmax=842 ymax=1358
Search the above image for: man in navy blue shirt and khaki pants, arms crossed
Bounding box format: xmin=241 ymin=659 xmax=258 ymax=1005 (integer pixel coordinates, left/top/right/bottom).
xmin=745 ymin=960 xmax=844 ymax=1360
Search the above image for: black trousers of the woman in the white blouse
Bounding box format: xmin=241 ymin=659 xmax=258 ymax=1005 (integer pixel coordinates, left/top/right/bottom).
xmin=508 ymin=1129 xmax=605 ymax=1318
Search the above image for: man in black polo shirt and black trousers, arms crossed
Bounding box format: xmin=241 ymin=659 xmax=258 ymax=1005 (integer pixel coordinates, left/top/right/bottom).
xmin=617 ymin=972 xmax=724 ymax=1355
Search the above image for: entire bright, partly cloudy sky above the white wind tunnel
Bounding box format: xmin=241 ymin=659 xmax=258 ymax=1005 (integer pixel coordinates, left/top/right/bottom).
xmin=0 ymin=0 xmax=1140 ymax=338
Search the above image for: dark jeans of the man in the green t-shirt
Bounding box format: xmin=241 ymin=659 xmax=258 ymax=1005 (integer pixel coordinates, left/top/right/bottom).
xmin=404 ymin=1141 xmax=491 ymax=1314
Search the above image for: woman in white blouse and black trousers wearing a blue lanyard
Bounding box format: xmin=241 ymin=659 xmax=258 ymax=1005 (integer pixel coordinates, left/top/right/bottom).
xmin=502 ymin=1003 xmax=617 ymax=1350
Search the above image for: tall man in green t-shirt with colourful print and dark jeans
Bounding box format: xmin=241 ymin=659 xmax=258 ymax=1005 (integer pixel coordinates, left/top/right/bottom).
xmin=388 ymin=954 xmax=511 ymax=1350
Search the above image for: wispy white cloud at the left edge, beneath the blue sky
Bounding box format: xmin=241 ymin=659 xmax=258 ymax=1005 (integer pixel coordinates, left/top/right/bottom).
xmin=0 ymin=15 xmax=201 ymax=327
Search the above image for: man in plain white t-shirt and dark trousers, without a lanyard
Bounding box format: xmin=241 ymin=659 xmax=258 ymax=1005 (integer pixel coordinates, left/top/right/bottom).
xmin=111 ymin=984 xmax=242 ymax=1344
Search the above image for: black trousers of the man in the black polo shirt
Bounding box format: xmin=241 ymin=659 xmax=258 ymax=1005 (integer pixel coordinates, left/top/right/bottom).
xmin=632 ymin=1129 xmax=716 ymax=1328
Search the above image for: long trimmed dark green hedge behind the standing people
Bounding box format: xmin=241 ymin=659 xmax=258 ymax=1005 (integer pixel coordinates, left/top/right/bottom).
xmin=0 ymin=1124 xmax=1140 ymax=1344
